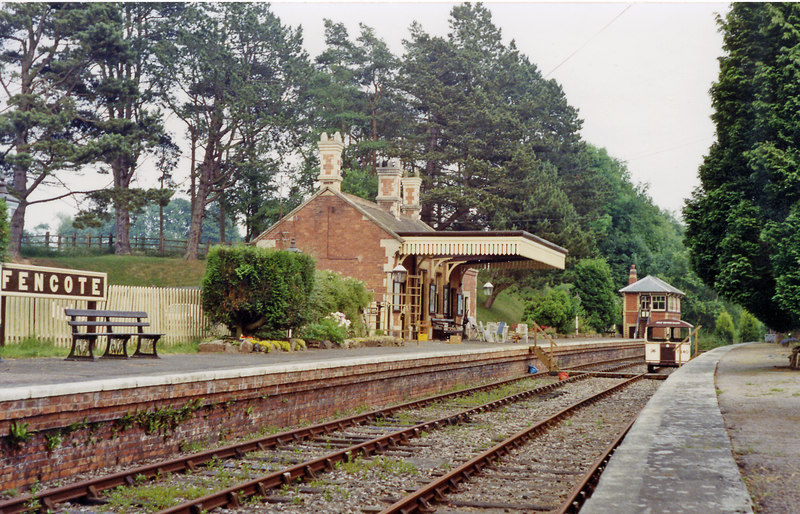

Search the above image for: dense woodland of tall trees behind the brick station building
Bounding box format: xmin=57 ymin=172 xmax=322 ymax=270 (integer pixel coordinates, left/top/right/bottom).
xmin=0 ymin=3 xmax=764 ymax=336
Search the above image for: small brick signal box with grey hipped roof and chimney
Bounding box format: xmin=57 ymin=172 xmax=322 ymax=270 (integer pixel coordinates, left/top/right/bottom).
xmin=619 ymin=265 xmax=691 ymax=340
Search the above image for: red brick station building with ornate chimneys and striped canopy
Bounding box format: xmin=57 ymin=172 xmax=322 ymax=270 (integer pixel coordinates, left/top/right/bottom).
xmin=253 ymin=133 xmax=567 ymax=339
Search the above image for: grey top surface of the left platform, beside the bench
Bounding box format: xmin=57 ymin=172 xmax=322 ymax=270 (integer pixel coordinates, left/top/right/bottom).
xmin=0 ymin=338 xmax=631 ymax=401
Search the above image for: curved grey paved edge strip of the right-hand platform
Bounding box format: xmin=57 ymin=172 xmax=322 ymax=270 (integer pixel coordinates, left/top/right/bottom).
xmin=581 ymin=345 xmax=757 ymax=514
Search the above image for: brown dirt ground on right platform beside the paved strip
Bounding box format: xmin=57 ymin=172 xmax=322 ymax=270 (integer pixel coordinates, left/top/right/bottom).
xmin=717 ymin=343 xmax=800 ymax=513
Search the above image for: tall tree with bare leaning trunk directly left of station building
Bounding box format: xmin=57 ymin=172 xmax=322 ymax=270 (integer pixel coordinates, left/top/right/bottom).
xmin=160 ymin=3 xmax=311 ymax=259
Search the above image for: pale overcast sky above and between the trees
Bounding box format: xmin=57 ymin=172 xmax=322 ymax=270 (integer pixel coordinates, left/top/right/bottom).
xmin=26 ymin=2 xmax=728 ymax=230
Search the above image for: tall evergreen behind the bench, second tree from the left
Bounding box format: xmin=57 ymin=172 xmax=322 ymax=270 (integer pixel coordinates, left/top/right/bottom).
xmin=76 ymin=3 xmax=182 ymax=255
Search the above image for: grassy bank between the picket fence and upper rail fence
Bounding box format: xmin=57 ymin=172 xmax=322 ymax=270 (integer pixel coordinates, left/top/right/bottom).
xmin=28 ymin=254 xmax=206 ymax=287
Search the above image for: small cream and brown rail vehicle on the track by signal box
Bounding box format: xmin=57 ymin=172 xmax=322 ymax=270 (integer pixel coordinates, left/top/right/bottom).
xmin=644 ymin=319 xmax=696 ymax=373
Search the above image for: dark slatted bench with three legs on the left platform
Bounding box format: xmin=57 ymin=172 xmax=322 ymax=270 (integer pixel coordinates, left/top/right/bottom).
xmin=64 ymin=309 xmax=164 ymax=360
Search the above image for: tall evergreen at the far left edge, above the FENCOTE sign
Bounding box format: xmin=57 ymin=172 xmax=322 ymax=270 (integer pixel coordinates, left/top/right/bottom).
xmin=0 ymin=3 xmax=105 ymax=258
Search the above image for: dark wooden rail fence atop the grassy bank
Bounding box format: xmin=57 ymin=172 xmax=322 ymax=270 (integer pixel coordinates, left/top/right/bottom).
xmin=22 ymin=232 xmax=228 ymax=256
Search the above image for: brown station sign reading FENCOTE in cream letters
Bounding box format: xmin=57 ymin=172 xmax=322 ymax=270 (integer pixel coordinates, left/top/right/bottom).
xmin=0 ymin=263 xmax=108 ymax=302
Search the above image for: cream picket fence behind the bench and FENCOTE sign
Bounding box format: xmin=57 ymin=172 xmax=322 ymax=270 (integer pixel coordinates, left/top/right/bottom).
xmin=6 ymin=285 xmax=224 ymax=347
